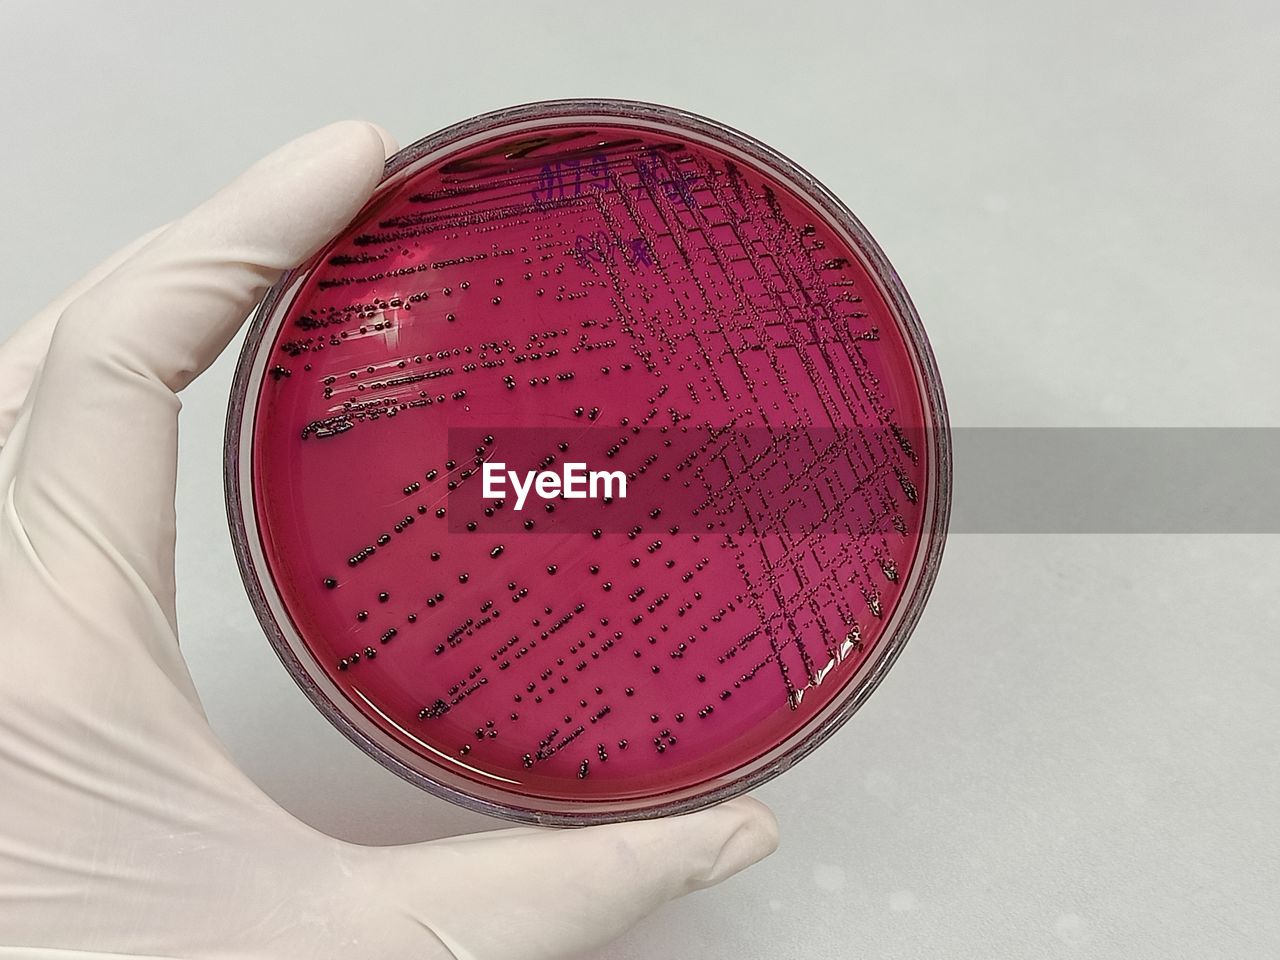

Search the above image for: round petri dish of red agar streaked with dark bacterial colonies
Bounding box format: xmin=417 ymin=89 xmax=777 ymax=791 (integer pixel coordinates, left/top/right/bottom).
xmin=225 ymin=100 xmax=951 ymax=826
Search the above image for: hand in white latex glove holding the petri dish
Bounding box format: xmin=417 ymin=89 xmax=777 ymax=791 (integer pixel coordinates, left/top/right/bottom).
xmin=0 ymin=123 xmax=777 ymax=960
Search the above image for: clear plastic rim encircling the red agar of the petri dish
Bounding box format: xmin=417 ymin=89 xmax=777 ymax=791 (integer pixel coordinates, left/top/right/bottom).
xmin=223 ymin=99 xmax=951 ymax=827
